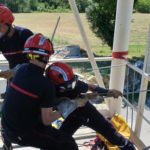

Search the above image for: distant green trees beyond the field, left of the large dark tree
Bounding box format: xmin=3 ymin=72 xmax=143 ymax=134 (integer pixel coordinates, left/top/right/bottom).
xmin=0 ymin=0 xmax=91 ymax=13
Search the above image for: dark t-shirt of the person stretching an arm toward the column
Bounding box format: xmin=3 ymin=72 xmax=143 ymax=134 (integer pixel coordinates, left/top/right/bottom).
xmin=56 ymin=80 xmax=88 ymax=99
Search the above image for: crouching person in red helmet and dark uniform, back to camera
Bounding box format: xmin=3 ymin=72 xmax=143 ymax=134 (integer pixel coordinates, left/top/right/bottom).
xmin=2 ymin=34 xmax=78 ymax=150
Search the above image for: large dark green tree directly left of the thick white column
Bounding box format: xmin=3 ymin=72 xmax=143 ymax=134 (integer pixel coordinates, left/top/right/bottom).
xmin=86 ymin=0 xmax=137 ymax=48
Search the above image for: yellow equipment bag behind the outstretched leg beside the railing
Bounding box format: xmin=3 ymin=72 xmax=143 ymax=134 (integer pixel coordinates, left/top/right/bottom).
xmin=97 ymin=114 xmax=131 ymax=150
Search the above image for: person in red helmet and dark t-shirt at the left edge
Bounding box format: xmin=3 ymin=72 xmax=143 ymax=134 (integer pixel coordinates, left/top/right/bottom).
xmin=0 ymin=4 xmax=33 ymax=79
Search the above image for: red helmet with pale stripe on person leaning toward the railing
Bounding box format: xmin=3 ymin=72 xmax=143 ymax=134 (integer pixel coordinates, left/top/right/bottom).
xmin=46 ymin=62 xmax=77 ymax=89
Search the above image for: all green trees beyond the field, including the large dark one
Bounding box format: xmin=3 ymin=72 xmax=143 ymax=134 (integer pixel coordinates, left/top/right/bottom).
xmin=0 ymin=0 xmax=150 ymax=48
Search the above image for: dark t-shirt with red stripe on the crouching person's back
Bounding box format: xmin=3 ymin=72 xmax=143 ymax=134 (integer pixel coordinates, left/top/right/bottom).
xmin=2 ymin=64 xmax=55 ymax=133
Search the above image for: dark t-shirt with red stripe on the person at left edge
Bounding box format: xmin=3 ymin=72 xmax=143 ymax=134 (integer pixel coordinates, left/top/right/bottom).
xmin=0 ymin=27 xmax=33 ymax=68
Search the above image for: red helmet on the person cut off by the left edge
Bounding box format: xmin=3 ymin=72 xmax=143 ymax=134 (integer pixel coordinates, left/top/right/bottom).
xmin=0 ymin=4 xmax=15 ymax=25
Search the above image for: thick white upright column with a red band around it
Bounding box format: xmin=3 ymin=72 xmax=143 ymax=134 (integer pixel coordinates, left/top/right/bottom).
xmin=109 ymin=0 xmax=134 ymax=114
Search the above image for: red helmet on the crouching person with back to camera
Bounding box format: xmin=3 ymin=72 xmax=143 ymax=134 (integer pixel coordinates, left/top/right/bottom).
xmin=24 ymin=33 xmax=54 ymax=56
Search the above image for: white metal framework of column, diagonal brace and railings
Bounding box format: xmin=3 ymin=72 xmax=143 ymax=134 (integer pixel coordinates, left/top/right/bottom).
xmin=0 ymin=0 xmax=150 ymax=145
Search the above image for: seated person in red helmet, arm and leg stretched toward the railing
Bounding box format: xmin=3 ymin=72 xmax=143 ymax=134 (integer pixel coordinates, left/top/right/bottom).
xmin=46 ymin=62 xmax=135 ymax=150
